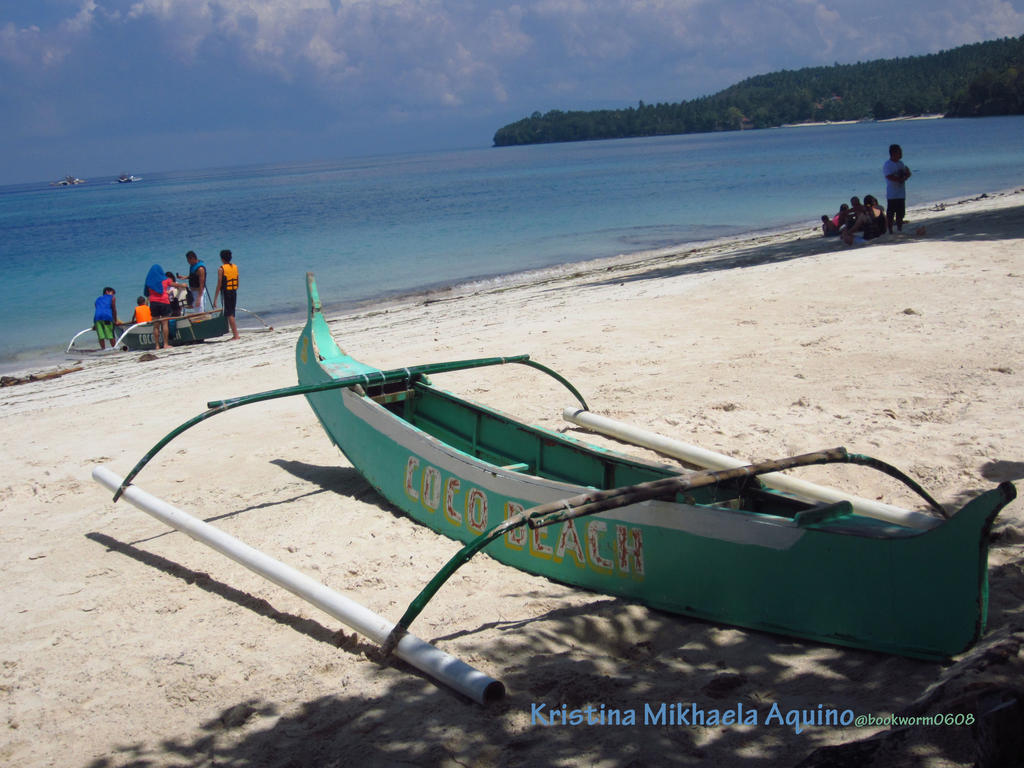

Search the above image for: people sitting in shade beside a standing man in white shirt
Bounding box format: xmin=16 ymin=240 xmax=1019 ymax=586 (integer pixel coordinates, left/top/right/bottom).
xmin=821 ymin=144 xmax=910 ymax=245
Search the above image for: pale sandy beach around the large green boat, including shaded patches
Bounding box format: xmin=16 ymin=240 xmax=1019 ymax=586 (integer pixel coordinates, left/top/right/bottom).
xmin=0 ymin=189 xmax=1024 ymax=768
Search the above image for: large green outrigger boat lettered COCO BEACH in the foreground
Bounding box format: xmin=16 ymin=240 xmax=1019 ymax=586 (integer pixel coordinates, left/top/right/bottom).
xmin=103 ymin=274 xmax=1016 ymax=671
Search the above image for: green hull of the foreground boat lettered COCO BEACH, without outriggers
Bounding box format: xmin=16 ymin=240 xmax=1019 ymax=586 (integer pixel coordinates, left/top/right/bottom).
xmin=296 ymin=278 xmax=1015 ymax=658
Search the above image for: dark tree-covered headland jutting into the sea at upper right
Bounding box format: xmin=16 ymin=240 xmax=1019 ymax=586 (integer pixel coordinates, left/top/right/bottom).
xmin=494 ymin=35 xmax=1024 ymax=146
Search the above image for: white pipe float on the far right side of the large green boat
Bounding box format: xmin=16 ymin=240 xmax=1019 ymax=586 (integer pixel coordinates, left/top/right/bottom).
xmin=562 ymin=408 xmax=941 ymax=530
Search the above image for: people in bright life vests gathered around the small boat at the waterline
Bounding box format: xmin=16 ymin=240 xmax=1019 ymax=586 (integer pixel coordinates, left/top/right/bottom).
xmin=92 ymin=249 xmax=241 ymax=349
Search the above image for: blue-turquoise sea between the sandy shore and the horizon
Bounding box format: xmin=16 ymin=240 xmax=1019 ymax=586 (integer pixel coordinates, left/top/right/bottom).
xmin=0 ymin=117 xmax=1024 ymax=373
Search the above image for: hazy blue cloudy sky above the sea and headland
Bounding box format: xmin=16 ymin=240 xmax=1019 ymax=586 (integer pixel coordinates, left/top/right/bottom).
xmin=0 ymin=0 xmax=1024 ymax=184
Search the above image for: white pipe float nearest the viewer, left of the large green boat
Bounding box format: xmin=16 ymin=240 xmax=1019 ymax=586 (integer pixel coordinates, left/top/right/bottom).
xmin=92 ymin=466 xmax=505 ymax=703
